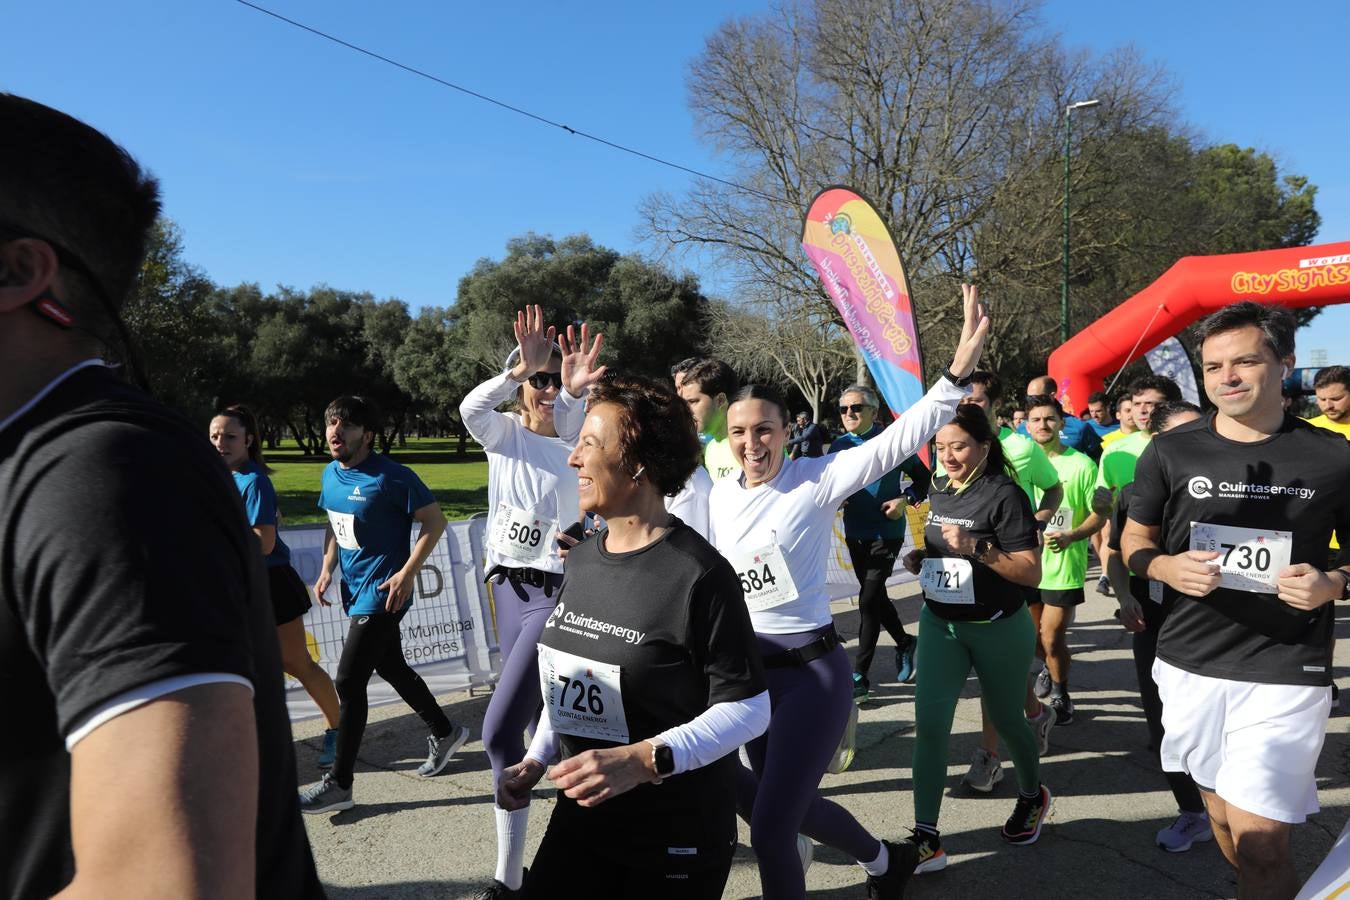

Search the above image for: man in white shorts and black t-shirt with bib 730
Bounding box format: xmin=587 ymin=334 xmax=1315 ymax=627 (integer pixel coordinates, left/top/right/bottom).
xmin=1121 ymin=302 xmax=1350 ymax=899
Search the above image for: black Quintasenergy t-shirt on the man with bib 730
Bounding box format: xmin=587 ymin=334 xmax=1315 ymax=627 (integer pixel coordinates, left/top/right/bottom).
xmin=1129 ymin=414 xmax=1350 ymax=685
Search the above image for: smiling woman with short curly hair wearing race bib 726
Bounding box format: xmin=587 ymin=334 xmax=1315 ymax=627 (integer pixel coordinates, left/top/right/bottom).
xmin=498 ymin=378 xmax=770 ymax=899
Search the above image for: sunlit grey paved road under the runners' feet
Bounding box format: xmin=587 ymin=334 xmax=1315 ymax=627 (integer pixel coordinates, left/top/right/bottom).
xmin=296 ymin=574 xmax=1350 ymax=900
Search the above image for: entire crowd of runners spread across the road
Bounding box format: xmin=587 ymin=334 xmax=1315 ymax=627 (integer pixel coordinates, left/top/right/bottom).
xmin=0 ymin=94 xmax=1350 ymax=900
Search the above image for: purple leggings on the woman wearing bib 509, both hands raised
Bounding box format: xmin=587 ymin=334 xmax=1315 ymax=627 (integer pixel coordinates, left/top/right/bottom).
xmin=483 ymin=580 xmax=558 ymax=785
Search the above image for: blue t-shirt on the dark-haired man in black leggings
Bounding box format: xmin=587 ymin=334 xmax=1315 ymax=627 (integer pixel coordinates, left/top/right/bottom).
xmin=319 ymin=453 xmax=435 ymax=615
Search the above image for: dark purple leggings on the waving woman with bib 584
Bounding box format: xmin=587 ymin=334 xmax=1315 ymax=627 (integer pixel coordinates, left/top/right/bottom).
xmin=736 ymin=625 xmax=880 ymax=899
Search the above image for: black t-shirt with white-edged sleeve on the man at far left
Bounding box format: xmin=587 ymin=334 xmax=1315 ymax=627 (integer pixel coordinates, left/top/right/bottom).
xmin=0 ymin=366 xmax=323 ymax=899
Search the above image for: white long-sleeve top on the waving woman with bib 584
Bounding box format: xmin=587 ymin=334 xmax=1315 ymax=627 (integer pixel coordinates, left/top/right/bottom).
xmin=709 ymin=378 xmax=967 ymax=634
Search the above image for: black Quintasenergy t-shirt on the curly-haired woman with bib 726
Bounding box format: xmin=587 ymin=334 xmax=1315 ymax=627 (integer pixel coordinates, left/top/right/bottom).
xmin=537 ymin=519 xmax=764 ymax=855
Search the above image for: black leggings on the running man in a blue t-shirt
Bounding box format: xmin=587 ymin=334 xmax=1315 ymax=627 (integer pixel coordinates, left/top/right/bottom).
xmin=332 ymin=606 xmax=451 ymax=788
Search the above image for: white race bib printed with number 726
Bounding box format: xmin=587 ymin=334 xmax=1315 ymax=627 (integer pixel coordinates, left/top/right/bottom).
xmin=537 ymin=644 xmax=629 ymax=743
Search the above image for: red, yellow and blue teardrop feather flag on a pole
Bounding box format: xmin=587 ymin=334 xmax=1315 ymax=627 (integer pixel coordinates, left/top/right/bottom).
xmin=802 ymin=186 xmax=923 ymax=416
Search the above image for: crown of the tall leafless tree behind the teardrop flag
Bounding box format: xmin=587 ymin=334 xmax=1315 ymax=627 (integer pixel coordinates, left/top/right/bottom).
xmin=644 ymin=0 xmax=1170 ymax=380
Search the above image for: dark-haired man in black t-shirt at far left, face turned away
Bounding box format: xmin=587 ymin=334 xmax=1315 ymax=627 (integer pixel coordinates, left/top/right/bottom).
xmin=0 ymin=93 xmax=323 ymax=899
